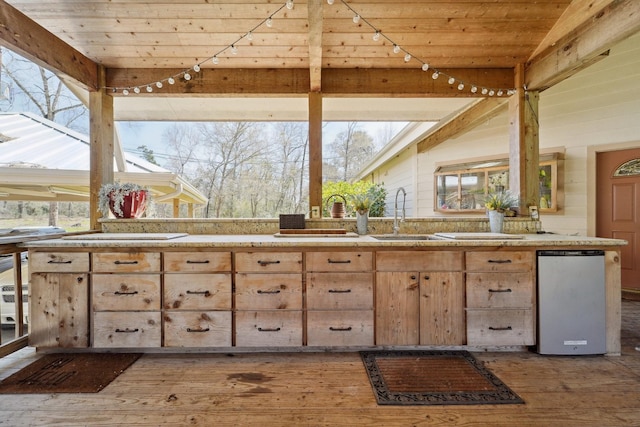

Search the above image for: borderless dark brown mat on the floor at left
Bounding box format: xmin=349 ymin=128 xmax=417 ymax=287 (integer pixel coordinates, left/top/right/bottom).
xmin=0 ymin=353 xmax=141 ymax=394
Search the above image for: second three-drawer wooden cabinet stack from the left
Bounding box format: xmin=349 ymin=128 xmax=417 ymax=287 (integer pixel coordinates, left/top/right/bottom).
xmin=162 ymin=252 xmax=232 ymax=347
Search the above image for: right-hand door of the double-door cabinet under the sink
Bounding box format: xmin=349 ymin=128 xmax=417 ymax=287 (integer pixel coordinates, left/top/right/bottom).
xmin=420 ymin=272 xmax=466 ymax=345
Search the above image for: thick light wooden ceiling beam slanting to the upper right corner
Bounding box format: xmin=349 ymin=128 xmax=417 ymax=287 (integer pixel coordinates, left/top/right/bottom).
xmin=525 ymin=0 xmax=640 ymax=91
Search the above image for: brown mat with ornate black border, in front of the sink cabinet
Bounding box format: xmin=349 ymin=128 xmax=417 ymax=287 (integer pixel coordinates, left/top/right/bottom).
xmin=360 ymin=351 xmax=524 ymax=405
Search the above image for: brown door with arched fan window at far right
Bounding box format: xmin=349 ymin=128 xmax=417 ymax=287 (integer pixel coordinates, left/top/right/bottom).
xmin=596 ymin=148 xmax=640 ymax=294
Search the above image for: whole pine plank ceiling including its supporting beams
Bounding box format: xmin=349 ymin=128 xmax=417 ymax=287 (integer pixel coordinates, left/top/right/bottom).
xmin=0 ymin=0 xmax=640 ymax=120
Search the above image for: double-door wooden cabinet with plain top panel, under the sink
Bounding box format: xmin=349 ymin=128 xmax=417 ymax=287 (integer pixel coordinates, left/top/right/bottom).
xmin=376 ymin=251 xmax=466 ymax=345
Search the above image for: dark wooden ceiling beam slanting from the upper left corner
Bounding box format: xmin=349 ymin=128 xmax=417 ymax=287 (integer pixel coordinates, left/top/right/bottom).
xmin=0 ymin=0 xmax=98 ymax=91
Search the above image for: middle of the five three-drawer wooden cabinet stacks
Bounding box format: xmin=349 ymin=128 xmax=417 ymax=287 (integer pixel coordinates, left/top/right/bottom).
xmin=235 ymin=252 xmax=303 ymax=347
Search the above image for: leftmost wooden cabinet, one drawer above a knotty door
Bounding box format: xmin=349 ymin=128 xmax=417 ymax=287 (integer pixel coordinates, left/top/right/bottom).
xmin=29 ymin=251 xmax=89 ymax=348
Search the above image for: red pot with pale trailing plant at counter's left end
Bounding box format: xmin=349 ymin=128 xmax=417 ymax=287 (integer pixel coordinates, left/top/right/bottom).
xmin=98 ymin=181 xmax=150 ymax=218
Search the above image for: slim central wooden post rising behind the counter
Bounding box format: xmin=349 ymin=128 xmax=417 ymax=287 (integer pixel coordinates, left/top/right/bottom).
xmin=309 ymin=92 xmax=322 ymax=216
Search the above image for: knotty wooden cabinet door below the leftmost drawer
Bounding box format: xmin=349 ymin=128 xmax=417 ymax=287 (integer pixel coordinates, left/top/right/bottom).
xmin=29 ymin=273 xmax=89 ymax=347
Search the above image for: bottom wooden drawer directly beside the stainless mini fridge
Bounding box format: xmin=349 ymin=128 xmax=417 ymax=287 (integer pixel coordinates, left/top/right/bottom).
xmin=467 ymin=310 xmax=535 ymax=346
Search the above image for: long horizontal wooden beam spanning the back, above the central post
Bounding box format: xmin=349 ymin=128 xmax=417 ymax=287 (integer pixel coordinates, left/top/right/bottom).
xmin=106 ymin=68 xmax=513 ymax=97
